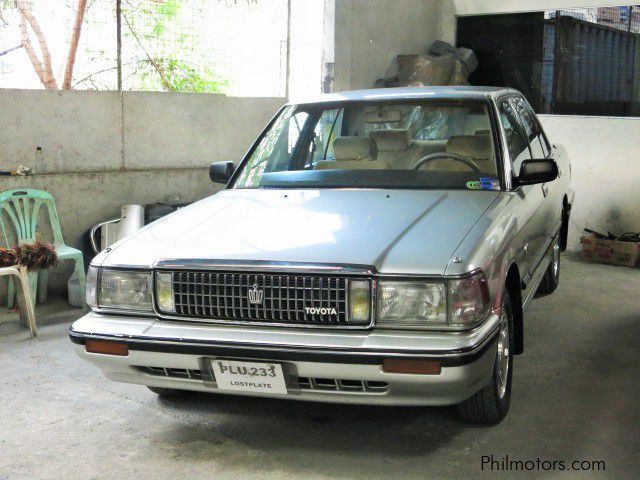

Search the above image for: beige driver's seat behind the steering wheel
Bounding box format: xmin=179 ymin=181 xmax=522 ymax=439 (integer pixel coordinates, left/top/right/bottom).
xmin=424 ymin=135 xmax=497 ymax=175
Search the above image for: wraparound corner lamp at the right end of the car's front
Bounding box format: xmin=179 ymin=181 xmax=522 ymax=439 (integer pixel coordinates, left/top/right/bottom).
xmin=449 ymin=271 xmax=490 ymax=326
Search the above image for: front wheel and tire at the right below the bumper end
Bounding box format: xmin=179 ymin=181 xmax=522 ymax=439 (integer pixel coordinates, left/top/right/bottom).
xmin=457 ymin=289 xmax=514 ymax=425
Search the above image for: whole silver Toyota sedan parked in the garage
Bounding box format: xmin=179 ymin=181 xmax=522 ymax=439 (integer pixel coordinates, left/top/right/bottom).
xmin=70 ymin=87 xmax=574 ymax=424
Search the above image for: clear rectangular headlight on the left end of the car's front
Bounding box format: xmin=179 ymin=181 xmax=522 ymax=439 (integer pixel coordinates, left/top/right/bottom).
xmin=87 ymin=267 xmax=153 ymax=312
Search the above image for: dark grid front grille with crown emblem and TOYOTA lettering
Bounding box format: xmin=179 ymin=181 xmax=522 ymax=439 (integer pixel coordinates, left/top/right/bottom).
xmin=172 ymin=271 xmax=369 ymax=326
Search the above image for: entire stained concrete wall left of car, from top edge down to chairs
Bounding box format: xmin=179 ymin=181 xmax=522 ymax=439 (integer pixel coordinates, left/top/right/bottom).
xmin=0 ymin=90 xmax=284 ymax=296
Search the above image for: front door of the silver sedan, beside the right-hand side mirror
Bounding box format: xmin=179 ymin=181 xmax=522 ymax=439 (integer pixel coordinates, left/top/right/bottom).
xmin=498 ymin=96 xmax=546 ymax=284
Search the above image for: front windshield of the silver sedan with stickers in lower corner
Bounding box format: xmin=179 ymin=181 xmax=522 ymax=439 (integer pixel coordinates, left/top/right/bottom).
xmin=233 ymin=100 xmax=500 ymax=190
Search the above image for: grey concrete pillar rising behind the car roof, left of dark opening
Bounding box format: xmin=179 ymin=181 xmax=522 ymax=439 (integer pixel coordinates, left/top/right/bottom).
xmin=335 ymin=0 xmax=455 ymax=91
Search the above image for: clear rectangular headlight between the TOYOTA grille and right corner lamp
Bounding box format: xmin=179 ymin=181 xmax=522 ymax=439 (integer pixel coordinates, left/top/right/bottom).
xmin=376 ymin=280 xmax=447 ymax=328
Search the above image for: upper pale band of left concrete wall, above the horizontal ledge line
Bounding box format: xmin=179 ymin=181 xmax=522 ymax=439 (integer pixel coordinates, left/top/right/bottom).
xmin=0 ymin=90 xmax=284 ymax=173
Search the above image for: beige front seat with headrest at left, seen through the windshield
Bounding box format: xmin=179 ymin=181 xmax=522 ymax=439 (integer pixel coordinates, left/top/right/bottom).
xmin=315 ymin=137 xmax=389 ymax=170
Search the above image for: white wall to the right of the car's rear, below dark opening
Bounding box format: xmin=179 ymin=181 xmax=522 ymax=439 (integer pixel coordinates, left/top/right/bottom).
xmin=539 ymin=115 xmax=640 ymax=250
